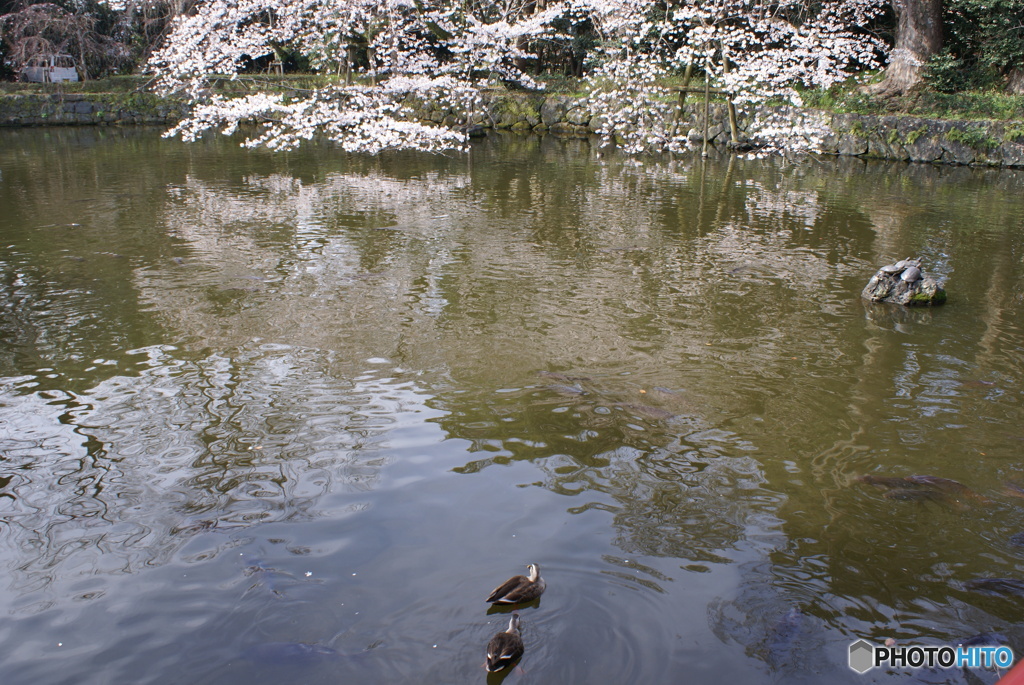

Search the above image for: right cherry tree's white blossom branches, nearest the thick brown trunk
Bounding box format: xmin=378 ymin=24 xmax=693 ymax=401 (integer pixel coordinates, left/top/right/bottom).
xmin=591 ymin=0 xmax=886 ymax=151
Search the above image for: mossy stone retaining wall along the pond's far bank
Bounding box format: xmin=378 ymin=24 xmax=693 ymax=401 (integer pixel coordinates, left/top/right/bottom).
xmin=0 ymin=90 xmax=1024 ymax=167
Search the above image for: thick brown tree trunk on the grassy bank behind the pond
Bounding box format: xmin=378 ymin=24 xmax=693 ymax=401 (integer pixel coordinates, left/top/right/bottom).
xmin=866 ymin=0 xmax=942 ymax=97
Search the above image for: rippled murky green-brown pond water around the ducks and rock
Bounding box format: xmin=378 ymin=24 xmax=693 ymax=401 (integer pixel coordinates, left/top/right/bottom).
xmin=0 ymin=128 xmax=1024 ymax=685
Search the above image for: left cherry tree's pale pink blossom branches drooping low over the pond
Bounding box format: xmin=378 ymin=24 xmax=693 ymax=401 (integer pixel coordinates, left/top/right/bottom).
xmin=151 ymin=0 xmax=558 ymax=153
